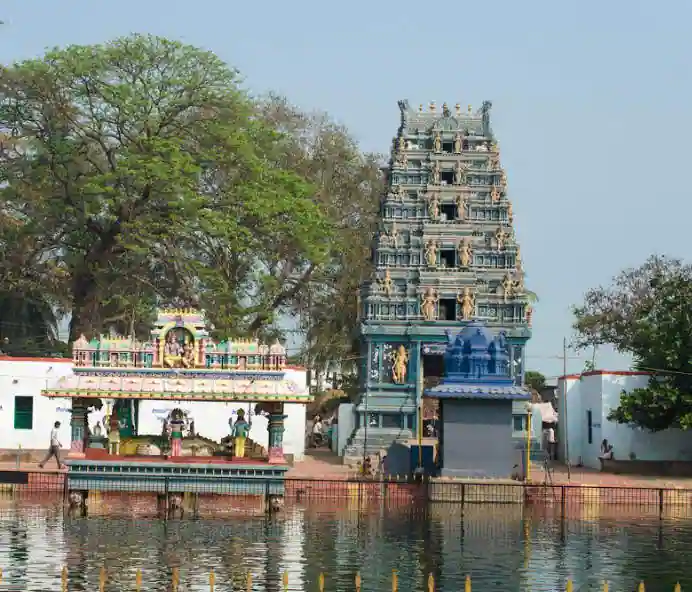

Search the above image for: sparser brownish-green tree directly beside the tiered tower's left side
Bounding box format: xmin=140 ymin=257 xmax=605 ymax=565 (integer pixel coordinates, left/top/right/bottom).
xmin=262 ymin=96 xmax=383 ymax=372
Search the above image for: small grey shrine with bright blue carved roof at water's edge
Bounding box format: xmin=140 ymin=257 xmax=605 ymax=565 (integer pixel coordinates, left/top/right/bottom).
xmin=424 ymin=321 xmax=531 ymax=478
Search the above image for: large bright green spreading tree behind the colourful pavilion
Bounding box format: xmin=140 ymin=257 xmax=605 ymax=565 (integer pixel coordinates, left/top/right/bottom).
xmin=0 ymin=35 xmax=329 ymax=341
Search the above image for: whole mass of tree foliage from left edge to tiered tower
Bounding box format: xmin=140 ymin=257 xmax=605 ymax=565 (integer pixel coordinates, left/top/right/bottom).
xmin=0 ymin=35 xmax=382 ymax=367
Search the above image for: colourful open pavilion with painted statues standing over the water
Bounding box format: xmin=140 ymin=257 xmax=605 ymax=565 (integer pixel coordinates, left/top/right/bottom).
xmin=42 ymin=309 xmax=310 ymax=506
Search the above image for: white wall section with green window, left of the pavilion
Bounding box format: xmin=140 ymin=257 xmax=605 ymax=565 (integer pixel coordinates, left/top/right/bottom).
xmin=0 ymin=359 xmax=72 ymax=450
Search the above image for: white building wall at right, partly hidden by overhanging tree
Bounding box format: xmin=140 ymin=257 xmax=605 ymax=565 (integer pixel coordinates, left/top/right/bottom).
xmin=558 ymin=371 xmax=692 ymax=469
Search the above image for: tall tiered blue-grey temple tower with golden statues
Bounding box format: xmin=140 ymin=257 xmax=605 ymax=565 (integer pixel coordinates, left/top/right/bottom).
xmin=346 ymin=101 xmax=532 ymax=456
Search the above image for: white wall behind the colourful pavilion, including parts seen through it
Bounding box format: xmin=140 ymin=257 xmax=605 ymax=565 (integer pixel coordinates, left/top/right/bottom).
xmin=0 ymin=359 xmax=306 ymax=461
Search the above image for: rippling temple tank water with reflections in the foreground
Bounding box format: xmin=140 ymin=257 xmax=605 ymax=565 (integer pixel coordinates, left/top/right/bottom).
xmin=0 ymin=504 xmax=692 ymax=592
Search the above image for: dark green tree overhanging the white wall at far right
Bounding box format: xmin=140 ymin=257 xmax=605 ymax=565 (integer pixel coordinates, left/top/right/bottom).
xmin=574 ymin=256 xmax=692 ymax=431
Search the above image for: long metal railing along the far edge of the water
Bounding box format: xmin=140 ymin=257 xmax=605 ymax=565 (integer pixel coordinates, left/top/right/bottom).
xmin=0 ymin=471 xmax=692 ymax=516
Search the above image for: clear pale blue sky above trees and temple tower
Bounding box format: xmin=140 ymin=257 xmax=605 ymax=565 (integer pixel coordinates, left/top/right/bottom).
xmin=0 ymin=0 xmax=692 ymax=376
